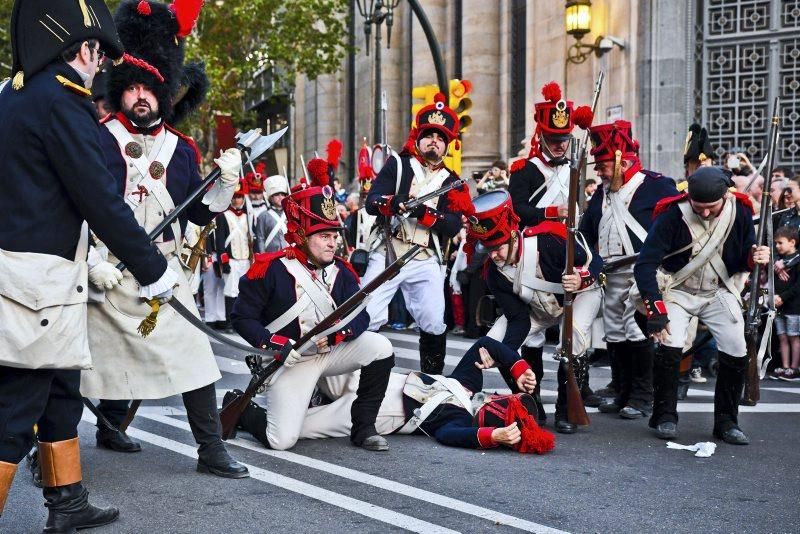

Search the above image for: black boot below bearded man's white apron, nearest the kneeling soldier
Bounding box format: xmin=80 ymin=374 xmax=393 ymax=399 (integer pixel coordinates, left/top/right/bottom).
xmin=183 ymin=383 xmax=250 ymax=478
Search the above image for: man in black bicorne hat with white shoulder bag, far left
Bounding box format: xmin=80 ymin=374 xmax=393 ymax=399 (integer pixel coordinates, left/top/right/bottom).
xmin=0 ymin=0 xmax=175 ymax=532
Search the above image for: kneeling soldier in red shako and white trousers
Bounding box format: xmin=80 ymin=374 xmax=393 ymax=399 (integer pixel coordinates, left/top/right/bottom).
xmin=223 ymin=168 xmax=394 ymax=451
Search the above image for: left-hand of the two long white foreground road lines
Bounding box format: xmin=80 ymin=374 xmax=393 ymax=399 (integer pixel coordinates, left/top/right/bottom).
xmin=83 ymin=411 xmax=459 ymax=534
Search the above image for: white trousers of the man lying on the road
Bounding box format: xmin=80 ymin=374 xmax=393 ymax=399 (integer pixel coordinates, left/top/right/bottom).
xmin=300 ymin=371 xmax=408 ymax=439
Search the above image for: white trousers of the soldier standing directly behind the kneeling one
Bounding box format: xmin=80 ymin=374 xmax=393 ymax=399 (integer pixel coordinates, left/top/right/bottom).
xmin=361 ymin=253 xmax=447 ymax=335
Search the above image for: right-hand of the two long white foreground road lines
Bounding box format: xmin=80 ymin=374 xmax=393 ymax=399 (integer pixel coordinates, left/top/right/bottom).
xmin=134 ymin=414 xmax=564 ymax=534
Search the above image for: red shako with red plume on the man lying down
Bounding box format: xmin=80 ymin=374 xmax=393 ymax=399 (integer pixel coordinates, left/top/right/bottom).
xmin=475 ymin=393 xmax=556 ymax=454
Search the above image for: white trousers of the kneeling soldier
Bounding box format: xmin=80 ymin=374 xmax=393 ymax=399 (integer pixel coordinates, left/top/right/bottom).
xmin=264 ymin=332 xmax=394 ymax=450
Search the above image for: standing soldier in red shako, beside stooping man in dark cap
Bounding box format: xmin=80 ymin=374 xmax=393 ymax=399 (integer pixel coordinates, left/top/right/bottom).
xmin=580 ymin=120 xmax=677 ymax=419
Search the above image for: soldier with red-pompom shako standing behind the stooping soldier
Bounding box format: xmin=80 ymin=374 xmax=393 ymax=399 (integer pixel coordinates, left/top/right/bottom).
xmin=508 ymin=82 xmax=592 ymax=228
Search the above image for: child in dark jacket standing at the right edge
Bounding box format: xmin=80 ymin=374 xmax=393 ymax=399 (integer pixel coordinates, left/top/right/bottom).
xmin=771 ymin=226 xmax=800 ymax=380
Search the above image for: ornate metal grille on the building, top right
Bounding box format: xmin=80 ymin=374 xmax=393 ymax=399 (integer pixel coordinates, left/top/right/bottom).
xmin=694 ymin=0 xmax=800 ymax=171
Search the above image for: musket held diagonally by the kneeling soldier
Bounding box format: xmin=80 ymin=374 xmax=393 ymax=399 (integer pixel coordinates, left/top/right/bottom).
xmin=219 ymin=245 xmax=423 ymax=439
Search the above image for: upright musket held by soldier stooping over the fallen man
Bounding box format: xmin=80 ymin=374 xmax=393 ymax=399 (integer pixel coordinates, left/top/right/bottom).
xmin=561 ymin=140 xmax=589 ymax=426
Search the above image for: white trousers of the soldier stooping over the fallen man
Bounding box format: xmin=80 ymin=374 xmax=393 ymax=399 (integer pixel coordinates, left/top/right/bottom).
xmin=487 ymin=287 xmax=602 ymax=356
